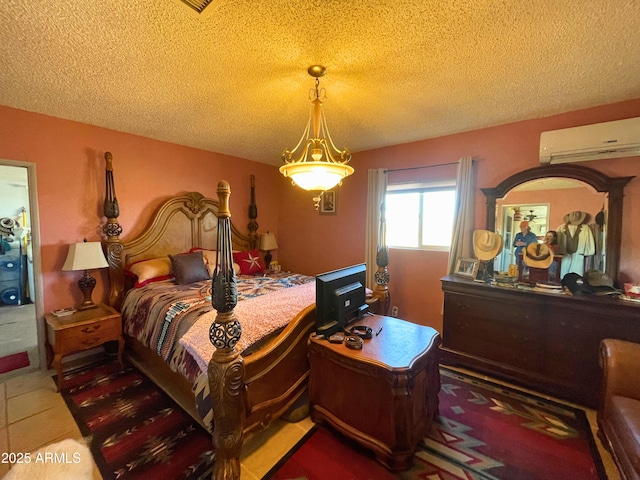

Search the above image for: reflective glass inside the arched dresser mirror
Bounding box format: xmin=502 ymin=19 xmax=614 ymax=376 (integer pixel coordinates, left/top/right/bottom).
xmin=494 ymin=177 xmax=607 ymax=274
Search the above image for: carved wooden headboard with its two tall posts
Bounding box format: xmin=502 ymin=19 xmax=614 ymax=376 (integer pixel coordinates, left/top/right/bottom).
xmin=104 ymin=152 xmax=258 ymax=309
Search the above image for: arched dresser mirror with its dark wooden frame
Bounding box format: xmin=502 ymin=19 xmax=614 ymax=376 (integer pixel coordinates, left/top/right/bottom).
xmin=481 ymin=164 xmax=634 ymax=281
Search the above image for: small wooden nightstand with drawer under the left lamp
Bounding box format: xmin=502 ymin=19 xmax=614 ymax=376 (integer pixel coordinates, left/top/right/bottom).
xmin=44 ymin=304 xmax=124 ymax=391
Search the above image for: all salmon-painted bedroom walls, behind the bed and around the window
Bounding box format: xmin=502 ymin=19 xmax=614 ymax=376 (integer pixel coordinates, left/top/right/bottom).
xmin=0 ymin=99 xmax=640 ymax=338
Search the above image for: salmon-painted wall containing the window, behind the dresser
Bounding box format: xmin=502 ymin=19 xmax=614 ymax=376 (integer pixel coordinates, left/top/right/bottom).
xmin=278 ymin=99 xmax=640 ymax=331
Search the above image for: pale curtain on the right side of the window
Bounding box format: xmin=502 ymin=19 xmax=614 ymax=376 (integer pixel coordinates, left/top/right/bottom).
xmin=447 ymin=157 xmax=475 ymax=274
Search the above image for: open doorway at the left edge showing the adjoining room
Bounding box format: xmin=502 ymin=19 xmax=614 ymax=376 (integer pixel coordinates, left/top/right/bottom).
xmin=0 ymin=159 xmax=44 ymax=381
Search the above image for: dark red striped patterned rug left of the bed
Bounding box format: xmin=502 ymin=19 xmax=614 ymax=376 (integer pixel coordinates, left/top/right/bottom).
xmin=62 ymin=362 xmax=213 ymax=480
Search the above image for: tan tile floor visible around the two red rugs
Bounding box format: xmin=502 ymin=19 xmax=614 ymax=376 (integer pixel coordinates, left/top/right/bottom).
xmin=0 ymin=364 xmax=620 ymax=480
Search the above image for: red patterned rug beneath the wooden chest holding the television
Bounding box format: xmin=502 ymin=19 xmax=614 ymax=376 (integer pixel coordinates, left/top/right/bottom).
xmin=264 ymin=367 xmax=607 ymax=480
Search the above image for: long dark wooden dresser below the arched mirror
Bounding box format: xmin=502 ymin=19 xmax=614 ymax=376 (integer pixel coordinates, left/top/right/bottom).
xmin=442 ymin=276 xmax=640 ymax=408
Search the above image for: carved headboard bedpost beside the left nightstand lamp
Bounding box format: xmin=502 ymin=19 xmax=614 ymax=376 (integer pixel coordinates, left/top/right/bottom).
xmin=103 ymin=152 xmax=124 ymax=309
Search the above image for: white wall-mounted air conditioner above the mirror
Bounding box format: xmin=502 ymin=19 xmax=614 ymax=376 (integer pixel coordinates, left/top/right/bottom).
xmin=540 ymin=117 xmax=640 ymax=164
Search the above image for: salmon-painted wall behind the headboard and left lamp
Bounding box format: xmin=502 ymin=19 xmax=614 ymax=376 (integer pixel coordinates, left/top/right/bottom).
xmin=0 ymin=106 xmax=280 ymax=311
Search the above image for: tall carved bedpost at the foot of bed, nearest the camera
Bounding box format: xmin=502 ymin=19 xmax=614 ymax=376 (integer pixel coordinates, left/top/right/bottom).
xmin=209 ymin=180 xmax=246 ymax=480
